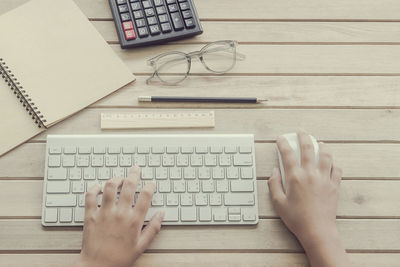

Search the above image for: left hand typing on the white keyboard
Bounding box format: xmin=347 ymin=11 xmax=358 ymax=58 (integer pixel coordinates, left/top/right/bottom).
xmin=75 ymin=167 xmax=164 ymax=267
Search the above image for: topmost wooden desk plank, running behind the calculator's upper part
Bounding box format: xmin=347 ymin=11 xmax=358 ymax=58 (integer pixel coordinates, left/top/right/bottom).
xmin=0 ymin=0 xmax=400 ymax=20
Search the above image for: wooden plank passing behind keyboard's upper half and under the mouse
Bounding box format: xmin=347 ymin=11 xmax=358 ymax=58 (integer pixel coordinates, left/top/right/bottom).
xmin=0 ymin=143 xmax=400 ymax=179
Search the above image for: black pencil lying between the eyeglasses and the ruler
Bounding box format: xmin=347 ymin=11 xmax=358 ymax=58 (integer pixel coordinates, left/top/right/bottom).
xmin=138 ymin=96 xmax=267 ymax=104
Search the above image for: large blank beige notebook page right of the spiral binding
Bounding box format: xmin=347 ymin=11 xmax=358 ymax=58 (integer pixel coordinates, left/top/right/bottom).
xmin=0 ymin=0 xmax=134 ymax=126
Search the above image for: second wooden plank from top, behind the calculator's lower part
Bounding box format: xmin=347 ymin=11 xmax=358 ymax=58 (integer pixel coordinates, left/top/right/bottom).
xmin=92 ymin=21 xmax=400 ymax=44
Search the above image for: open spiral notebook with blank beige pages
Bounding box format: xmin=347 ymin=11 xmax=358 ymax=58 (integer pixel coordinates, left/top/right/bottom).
xmin=0 ymin=0 xmax=135 ymax=156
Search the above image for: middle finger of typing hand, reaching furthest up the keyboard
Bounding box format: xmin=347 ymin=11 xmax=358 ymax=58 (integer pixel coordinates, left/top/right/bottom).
xmin=118 ymin=166 xmax=140 ymax=208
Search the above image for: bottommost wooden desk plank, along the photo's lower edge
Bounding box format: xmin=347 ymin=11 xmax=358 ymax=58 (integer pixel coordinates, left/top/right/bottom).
xmin=0 ymin=253 xmax=400 ymax=267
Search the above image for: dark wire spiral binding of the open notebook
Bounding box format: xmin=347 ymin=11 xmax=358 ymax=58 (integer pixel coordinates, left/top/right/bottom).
xmin=0 ymin=58 xmax=46 ymax=128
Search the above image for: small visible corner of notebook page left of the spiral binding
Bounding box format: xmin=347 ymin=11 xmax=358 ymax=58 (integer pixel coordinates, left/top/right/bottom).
xmin=0 ymin=79 xmax=44 ymax=156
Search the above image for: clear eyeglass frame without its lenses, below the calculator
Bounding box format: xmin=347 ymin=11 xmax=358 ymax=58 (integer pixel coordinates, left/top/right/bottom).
xmin=146 ymin=40 xmax=246 ymax=85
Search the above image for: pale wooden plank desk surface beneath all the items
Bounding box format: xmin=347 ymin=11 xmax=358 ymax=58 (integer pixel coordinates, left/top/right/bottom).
xmin=0 ymin=0 xmax=400 ymax=266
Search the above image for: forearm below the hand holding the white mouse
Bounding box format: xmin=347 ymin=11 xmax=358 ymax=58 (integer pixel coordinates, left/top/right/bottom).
xmin=300 ymin=228 xmax=351 ymax=267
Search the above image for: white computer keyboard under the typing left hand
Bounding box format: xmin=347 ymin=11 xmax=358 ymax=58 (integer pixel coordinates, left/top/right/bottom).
xmin=42 ymin=134 xmax=258 ymax=226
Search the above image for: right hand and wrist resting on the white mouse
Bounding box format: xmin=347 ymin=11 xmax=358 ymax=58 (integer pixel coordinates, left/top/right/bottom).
xmin=268 ymin=131 xmax=350 ymax=267
